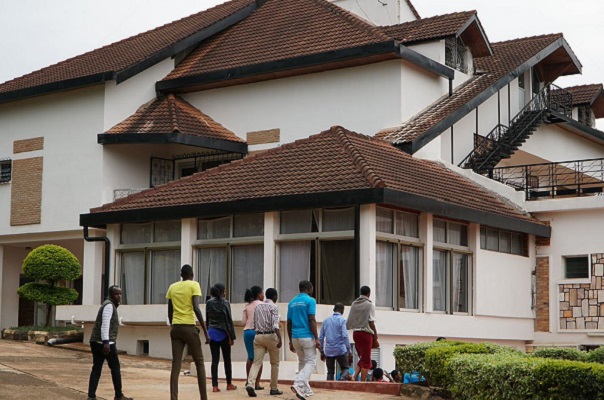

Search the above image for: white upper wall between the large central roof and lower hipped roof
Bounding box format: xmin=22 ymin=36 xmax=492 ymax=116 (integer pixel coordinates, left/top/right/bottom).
xmin=183 ymin=60 xmax=401 ymax=144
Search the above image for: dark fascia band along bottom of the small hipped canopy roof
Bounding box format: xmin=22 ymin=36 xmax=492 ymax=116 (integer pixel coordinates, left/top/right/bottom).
xmin=97 ymin=133 xmax=248 ymax=154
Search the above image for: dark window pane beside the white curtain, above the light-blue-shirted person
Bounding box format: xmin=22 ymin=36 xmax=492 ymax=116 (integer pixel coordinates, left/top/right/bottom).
xmin=318 ymin=240 xmax=356 ymax=304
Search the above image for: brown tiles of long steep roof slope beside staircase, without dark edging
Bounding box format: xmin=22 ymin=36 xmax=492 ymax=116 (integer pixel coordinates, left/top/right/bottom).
xmin=376 ymin=34 xmax=562 ymax=144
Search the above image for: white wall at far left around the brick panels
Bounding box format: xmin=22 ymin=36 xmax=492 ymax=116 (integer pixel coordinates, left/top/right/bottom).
xmin=0 ymin=86 xmax=103 ymax=235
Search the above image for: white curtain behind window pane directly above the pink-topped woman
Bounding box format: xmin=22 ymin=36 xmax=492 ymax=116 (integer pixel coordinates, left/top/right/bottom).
xmin=231 ymin=244 xmax=264 ymax=299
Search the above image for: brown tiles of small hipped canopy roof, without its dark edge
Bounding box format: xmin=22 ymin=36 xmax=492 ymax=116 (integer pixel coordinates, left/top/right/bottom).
xmin=105 ymin=94 xmax=244 ymax=142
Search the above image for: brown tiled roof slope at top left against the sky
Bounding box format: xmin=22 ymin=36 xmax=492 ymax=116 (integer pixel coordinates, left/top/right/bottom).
xmin=0 ymin=0 xmax=254 ymax=99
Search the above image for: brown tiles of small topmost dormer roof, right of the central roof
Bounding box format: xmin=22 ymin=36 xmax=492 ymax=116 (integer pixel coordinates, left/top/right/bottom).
xmin=382 ymin=11 xmax=476 ymax=43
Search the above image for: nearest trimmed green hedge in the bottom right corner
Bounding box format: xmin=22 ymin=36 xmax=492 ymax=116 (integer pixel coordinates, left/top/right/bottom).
xmin=447 ymin=354 xmax=604 ymax=400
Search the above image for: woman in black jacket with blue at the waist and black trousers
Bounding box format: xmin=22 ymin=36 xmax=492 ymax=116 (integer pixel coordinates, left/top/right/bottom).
xmin=206 ymin=283 xmax=237 ymax=392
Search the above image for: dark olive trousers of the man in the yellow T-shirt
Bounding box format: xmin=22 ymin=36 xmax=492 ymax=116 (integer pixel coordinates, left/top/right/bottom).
xmin=170 ymin=325 xmax=208 ymax=400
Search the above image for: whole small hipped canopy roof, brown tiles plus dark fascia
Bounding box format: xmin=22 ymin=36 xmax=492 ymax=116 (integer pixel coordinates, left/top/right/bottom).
xmin=98 ymin=94 xmax=247 ymax=153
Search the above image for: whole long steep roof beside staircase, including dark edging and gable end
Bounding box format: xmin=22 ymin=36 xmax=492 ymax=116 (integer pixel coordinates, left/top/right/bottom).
xmin=376 ymin=34 xmax=581 ymax=154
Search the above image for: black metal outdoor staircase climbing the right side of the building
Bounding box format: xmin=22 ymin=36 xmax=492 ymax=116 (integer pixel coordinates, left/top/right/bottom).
xmin=459 ymin=85 xmax=572 ymax=176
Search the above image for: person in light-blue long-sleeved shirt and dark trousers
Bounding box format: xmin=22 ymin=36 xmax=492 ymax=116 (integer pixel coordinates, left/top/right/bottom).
xmin=319 ymin=303 xmax=352 ymax=381
